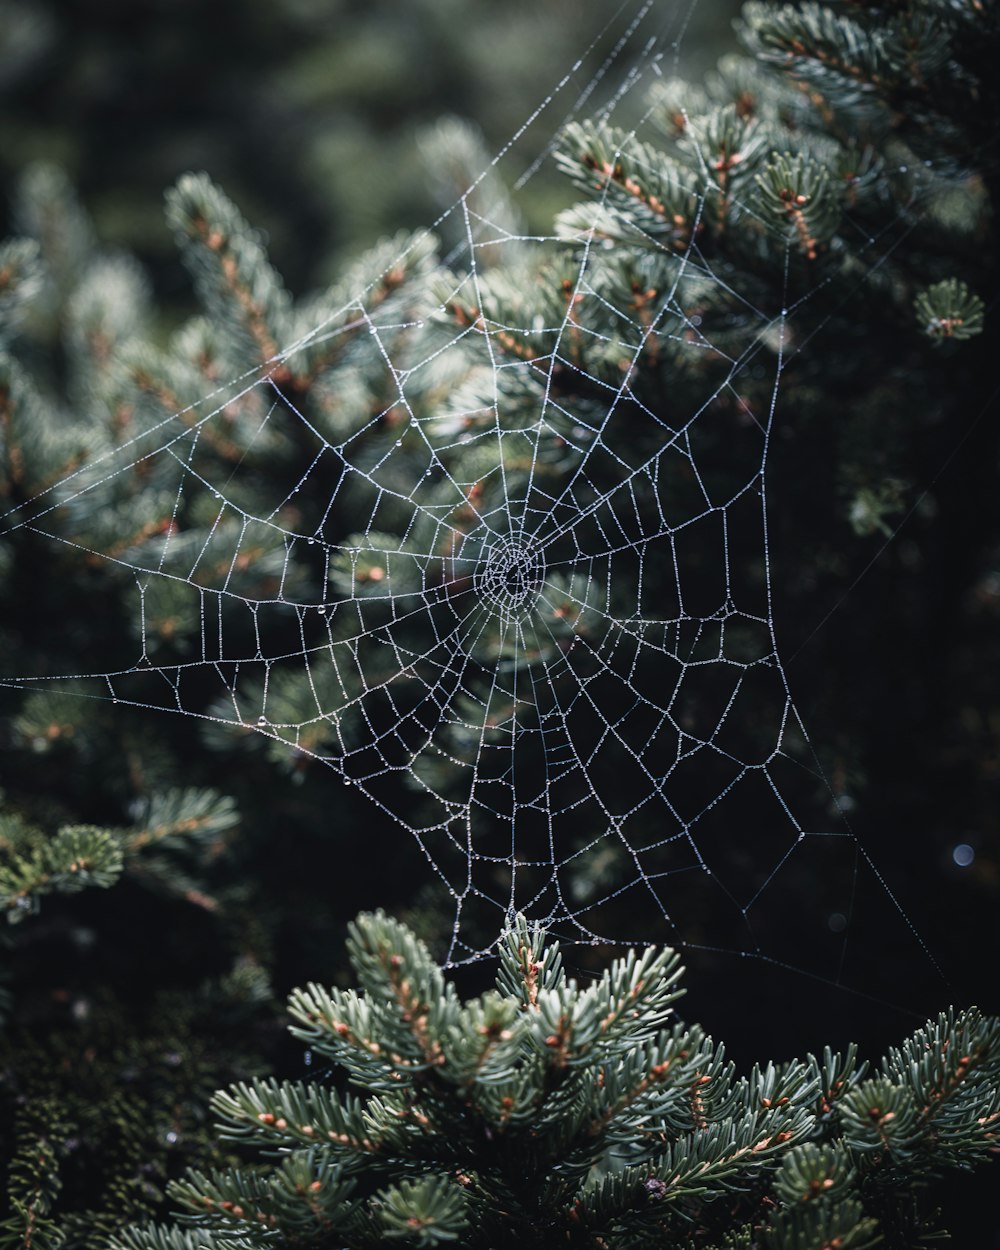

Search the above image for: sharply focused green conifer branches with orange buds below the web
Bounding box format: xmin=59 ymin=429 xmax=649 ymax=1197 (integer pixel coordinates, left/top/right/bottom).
xmin=115 ymin=913 xmax=1000 ymax=1250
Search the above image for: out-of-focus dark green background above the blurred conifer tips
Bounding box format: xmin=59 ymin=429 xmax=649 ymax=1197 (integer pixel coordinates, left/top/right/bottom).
xmin=0 ymin=0 xmax=738 ymax=304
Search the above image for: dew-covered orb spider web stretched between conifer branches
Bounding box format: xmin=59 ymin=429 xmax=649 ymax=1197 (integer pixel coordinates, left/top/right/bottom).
xmin=3 ymin=4 xmax=940 ymax=995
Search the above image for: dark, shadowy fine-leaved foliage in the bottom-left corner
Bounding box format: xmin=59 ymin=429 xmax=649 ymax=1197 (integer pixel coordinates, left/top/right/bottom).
xmin=0 ymin=964 xmax=274 ymax=1250
